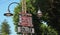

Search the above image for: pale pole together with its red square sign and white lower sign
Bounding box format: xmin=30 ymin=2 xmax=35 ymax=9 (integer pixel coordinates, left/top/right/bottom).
xmin=18 ymin=0 xmax=34 ymax=35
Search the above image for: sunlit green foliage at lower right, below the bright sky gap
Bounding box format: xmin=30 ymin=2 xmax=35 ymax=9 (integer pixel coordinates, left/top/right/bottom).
xmin=40 ymin=24 xmax=58 ymax=35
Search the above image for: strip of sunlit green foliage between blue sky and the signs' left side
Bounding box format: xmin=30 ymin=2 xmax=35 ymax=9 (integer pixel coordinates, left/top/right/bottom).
xmin=13 ymin=3 xmax=22 ymax=32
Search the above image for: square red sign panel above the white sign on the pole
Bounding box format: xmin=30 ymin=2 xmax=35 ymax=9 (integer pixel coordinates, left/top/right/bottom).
xmin=20 ymin=15 xmax=32 ymax=26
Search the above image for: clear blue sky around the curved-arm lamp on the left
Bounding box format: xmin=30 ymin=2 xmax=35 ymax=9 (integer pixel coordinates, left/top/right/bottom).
xmin=0 ymin=0 xmax=20 ymax=35
